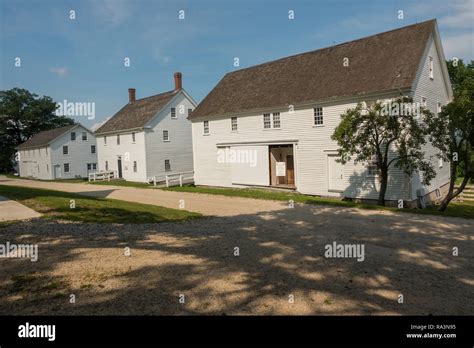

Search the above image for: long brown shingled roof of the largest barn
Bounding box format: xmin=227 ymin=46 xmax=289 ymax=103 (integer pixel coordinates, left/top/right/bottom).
xmin=190 ymin=20 xmax=436 ymax=119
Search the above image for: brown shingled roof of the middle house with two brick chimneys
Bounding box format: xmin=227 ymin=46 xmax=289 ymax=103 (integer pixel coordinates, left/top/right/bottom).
xmin=95 ymin=90 xmax=179 ymax=134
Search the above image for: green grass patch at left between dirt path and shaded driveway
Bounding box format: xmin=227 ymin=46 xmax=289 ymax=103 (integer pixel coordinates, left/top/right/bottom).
xmin=0 ymin=185 xmax=202 ymax=223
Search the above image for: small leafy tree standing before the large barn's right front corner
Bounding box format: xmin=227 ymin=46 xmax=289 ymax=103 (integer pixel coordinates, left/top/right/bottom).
xmin=331 ymin=97 xmax=435 ymax=205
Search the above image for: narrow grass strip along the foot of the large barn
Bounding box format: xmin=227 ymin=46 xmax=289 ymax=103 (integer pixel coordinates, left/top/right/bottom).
xmin=162 ymin=185 xmax=474 ymax=219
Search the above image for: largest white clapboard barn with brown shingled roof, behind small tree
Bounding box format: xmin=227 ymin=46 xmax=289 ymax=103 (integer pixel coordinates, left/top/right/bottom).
xmin=190 ymin=20 xmax=452 ymax=207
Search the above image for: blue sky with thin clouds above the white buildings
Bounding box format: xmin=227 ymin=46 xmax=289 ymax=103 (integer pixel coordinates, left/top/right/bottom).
xmin=0 ymin=0 xmax=474 ymax=127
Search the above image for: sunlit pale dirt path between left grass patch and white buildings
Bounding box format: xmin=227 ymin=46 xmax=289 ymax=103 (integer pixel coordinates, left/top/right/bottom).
xmin=0 ymin=176 xmax=287 ymax=216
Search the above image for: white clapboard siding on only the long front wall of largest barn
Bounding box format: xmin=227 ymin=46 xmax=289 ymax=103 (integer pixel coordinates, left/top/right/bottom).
xmin=193 ymin=94 xmax=410 ymax=199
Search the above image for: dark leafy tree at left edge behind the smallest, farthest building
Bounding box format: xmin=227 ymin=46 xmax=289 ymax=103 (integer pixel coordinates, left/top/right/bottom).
xmin=0 ymin=88 xmax=74 ymax=172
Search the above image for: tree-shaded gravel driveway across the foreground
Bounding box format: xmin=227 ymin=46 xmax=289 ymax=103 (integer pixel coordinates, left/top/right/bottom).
xmin=0 ymin=205 xmax=474 ymax=315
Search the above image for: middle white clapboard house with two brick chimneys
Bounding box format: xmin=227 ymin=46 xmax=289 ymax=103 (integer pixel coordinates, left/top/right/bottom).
xmin=95 ymin=72 xmax=197 ymax=182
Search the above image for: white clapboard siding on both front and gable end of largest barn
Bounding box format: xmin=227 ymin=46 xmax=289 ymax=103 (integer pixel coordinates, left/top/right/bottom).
xmin=193 ymin=29 xmax=451 ymax=204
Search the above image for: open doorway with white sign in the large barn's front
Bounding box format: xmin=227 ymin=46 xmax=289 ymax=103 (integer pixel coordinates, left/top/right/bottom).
xmin=269 ymin=145 xmax=296 ymax=189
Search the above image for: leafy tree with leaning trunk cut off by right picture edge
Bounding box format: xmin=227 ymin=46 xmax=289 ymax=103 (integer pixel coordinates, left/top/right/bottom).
xmin=425 ymin=60 xmax=474 ymax=211
